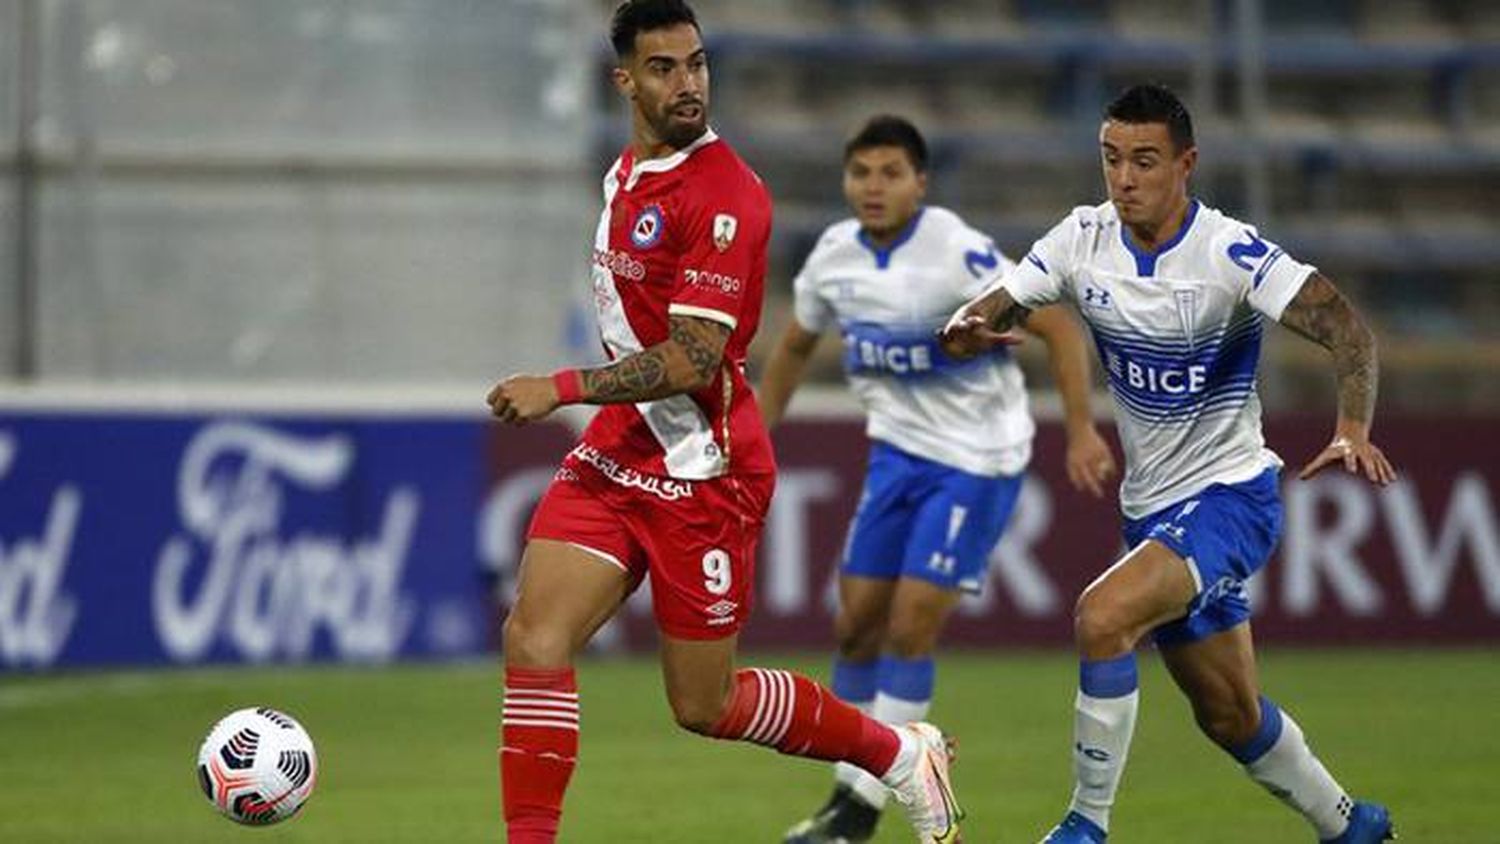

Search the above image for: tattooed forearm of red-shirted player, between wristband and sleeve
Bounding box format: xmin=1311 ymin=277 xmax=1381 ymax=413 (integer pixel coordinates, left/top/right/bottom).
xmin=579 ymin=316 xmax=731 ymax=405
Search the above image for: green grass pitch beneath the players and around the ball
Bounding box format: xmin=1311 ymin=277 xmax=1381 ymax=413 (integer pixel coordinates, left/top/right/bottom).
xmin=0 ymin=651 xmax=1500 ymax=844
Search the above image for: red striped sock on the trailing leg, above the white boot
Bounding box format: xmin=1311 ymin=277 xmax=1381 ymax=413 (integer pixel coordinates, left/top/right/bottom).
xmin=713 ymin=669 xmax=902 ymax=777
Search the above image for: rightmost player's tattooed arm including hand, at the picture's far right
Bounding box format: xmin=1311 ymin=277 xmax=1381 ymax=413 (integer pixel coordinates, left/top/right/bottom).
xmin=1281 ymin=273 xmax=1397 ymax=484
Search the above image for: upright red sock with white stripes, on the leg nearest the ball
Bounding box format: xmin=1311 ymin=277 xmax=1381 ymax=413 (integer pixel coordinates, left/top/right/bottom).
xmin=500 ymin=667 xmax=578 ymax=844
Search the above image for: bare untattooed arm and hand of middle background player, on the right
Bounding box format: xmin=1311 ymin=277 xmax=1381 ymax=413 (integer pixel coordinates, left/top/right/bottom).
xmin=1023 ymin=304 xmax=1115 ymax=498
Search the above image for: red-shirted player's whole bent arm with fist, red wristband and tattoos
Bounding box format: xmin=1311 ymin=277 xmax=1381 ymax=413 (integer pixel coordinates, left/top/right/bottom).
xmin=486 ymin=316 xmax=731 ymax=424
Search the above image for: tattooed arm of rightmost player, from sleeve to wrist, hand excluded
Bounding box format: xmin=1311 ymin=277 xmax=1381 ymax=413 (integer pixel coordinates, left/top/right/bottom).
xmin=1281 ymin=273 xmax=1380 ymax=424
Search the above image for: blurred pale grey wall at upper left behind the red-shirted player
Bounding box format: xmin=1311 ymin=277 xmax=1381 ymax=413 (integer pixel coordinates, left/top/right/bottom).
xmin=0 ymin=0 xmax=599 ymax=382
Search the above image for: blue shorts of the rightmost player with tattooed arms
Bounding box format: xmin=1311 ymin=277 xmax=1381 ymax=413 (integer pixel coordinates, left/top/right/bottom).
xmin=1125 ymin=469 xmax=1281 ymax=646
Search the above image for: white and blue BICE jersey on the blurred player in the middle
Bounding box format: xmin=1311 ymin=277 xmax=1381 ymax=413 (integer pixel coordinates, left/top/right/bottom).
xmin=795 ymin=205 xmax=1035 ymax=477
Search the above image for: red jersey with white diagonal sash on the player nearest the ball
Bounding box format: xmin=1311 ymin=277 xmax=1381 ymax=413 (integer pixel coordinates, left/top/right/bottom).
xmin=584 ymin=130 xmax=776 ymax=480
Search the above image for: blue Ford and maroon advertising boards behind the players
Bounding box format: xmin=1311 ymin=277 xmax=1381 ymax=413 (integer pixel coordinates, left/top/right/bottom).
xmin=0 ymin=406 xmax=1500 ymax=670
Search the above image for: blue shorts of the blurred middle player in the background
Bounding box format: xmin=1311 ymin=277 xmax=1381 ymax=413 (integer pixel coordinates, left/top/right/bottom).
xmin=839 ymin=441 xmax=1022 ymax=594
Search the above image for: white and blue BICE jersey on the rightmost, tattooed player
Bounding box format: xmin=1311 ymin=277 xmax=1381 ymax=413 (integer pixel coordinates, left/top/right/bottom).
xmin=1001 ymin=199 xmax=1314 ymax=519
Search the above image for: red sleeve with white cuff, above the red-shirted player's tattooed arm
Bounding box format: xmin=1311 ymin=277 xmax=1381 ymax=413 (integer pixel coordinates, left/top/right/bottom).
xmin=668 ymin=173 xmax=771 ymax=328
